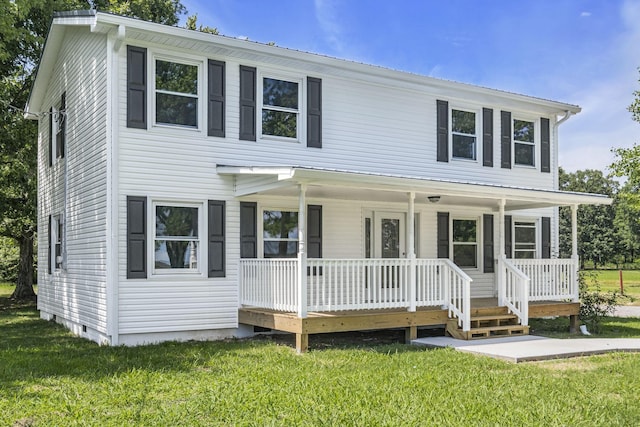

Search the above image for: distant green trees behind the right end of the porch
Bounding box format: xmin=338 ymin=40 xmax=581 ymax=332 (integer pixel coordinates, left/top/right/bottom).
xmin=559 ymin=168 xmax=618 ymax=268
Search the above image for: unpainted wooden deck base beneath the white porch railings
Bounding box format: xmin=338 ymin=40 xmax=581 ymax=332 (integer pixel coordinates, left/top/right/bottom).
xmin=238 ymin=298 xmax=580 ymax=353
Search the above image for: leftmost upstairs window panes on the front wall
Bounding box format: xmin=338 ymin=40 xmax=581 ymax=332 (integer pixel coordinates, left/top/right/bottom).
xmin=155 ymin=59 xmax=199 ymax=128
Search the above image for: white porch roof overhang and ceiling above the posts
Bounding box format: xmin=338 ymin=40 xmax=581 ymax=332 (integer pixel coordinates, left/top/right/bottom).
xmin=217 ymin=165 xmax=612 ymax=211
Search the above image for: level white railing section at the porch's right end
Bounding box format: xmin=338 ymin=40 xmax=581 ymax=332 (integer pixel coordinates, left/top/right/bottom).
xmin=510 ymin=258 xmax=578 ymax=302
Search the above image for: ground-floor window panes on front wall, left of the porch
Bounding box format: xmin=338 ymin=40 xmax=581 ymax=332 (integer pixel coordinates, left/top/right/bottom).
xmin=154 ymin=204 xmax=200 ymax=272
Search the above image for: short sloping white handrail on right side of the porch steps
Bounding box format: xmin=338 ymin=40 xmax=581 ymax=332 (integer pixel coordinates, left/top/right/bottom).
xmin=498 ymin=258 xmax=529 ymax=326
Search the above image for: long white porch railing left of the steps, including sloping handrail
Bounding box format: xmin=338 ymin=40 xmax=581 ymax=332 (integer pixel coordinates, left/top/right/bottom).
xmin=239 ymin=258 xmax=472 ymax=330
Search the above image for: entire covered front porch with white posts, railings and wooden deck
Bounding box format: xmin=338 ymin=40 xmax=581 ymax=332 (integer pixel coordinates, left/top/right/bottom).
xmin=218 ymin=166 xmax=611 ymax=351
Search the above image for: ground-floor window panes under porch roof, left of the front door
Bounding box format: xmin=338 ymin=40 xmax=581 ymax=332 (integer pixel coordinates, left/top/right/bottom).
xmin=262 ymin=210 xmax=298 ymax=258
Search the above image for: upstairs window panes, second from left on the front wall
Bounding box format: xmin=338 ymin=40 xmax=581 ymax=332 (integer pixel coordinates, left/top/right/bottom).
xmin=262 ymin=77 xmax=300 ymax=140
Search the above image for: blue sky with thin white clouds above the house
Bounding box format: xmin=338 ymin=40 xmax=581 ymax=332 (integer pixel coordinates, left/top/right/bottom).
xmin=182 ymin=0 xmax=640 ymax=171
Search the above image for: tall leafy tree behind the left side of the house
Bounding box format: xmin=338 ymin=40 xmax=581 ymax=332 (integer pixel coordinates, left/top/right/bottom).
xmin=0 ymin=0 xmax=186 ymax=299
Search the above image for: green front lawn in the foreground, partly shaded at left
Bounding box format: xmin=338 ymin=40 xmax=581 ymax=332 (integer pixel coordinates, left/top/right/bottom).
xmin=0 ymin=285 xmax=640 ymax=426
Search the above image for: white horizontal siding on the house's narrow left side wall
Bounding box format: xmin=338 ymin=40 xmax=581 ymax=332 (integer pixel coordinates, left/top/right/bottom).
xmin=38 ymin=28 xmax=107 ymax=333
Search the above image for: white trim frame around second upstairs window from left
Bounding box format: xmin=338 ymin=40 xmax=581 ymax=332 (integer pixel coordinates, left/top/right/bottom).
xmin=256 ymin=69 xmax=307 ymax=143
